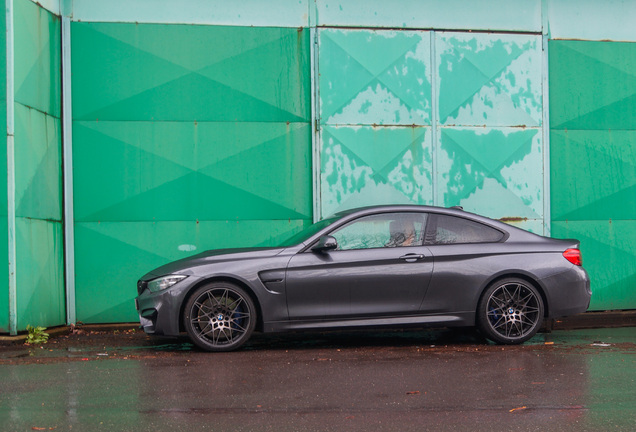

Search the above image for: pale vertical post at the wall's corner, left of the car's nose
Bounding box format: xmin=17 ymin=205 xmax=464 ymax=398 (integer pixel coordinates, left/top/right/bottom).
xmin=61 ymin=13 xmax=76 ymax=324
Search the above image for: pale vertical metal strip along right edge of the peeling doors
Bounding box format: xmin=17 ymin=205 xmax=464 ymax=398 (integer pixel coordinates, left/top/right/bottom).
xmin=541 ymin=0 xmax=552 ymax=236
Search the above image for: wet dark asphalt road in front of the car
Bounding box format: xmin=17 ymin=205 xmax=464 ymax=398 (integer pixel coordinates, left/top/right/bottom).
xmin=0 ymin=327 xmax=636 ymax=431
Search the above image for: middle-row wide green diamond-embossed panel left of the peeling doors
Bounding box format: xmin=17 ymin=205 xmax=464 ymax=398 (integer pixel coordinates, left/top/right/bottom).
xmin=73 ymin=122 xmax=311 ymax=221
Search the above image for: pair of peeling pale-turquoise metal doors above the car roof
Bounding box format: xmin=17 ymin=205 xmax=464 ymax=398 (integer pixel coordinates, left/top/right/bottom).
xmin=319 ymin=29 xmax=544 ymax=233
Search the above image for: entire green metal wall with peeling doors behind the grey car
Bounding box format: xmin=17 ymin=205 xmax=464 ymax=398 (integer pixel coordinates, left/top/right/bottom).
xmin=0 ymin=0 xmax=636 ymax=332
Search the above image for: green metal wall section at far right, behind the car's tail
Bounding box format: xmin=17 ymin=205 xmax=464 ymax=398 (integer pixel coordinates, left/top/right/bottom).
xmin=550 ymin=41 xmax=636 ymax=310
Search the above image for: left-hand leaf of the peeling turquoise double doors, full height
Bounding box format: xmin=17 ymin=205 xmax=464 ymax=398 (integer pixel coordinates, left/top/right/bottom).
xmin=319 ymin=29 xmax=432 ymax=217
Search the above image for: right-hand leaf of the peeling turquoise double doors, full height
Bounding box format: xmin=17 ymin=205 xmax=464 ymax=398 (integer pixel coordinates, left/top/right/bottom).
xmin=435 ymin=32 xmax=543 ymax=233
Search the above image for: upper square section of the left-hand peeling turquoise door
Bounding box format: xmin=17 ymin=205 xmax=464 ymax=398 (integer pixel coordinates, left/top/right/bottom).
xmin=319 ymin=29 xmax=431 ymax=125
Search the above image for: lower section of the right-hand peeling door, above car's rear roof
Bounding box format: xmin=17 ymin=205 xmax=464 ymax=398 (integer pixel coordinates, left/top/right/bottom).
xmin=437 ymin=128 xmax=543 ymax=219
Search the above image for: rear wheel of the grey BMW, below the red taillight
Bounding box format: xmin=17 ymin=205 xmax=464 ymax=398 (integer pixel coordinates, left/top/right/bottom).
xmin=477 ymin=278 xmax=544 ymax=345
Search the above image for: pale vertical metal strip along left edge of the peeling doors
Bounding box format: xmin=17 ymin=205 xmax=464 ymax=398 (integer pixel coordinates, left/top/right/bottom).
xmin=309 ymin=1 xmax=322 ymax=222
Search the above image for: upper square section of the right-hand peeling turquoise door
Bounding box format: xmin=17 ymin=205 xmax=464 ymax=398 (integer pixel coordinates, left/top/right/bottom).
xmin=436 ymin=33 xmax=542 ymax=127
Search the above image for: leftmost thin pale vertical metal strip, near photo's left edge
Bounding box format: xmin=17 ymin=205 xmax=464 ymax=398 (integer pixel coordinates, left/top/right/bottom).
xmin=5 ymin=0 xmax=18 ymax=335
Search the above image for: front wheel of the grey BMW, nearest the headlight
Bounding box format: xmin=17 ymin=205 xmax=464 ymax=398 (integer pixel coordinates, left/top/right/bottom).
xmin=183 ymin=282 xmax=257 ymax=351
